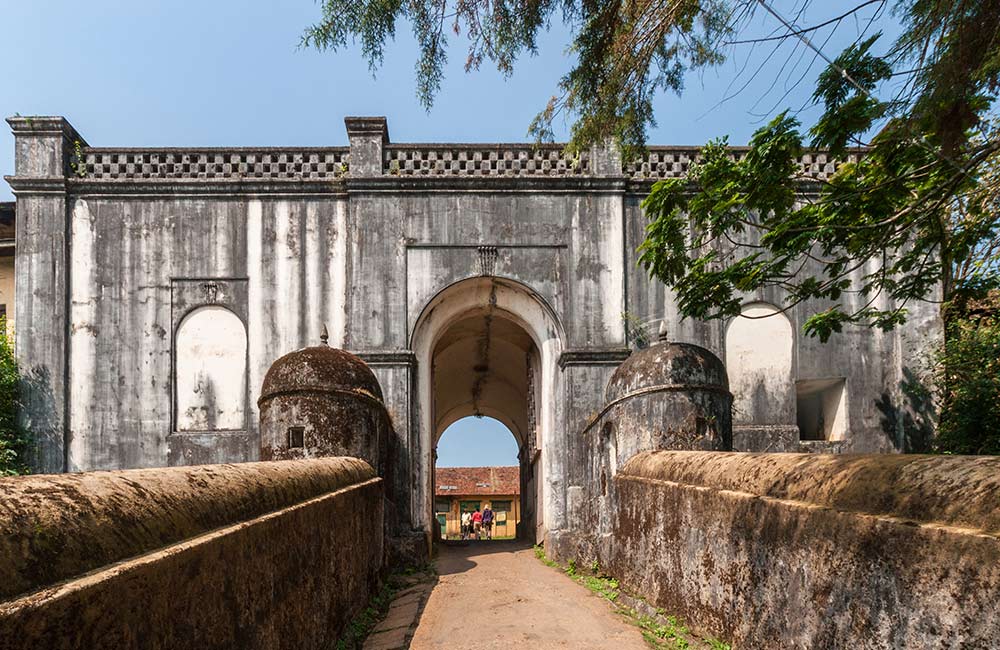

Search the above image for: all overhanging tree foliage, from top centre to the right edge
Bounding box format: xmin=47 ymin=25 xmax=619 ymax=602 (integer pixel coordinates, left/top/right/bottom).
xmin=303 ymin=0 xmax=1000 ymax=340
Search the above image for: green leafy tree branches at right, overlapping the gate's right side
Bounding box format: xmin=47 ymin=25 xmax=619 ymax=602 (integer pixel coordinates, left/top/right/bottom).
xmin=640 ymin=0 xmax=1000 ymax=340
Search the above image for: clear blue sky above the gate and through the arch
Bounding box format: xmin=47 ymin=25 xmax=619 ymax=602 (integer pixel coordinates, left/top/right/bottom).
xmin=0 ymin=0 xmax=897 ymax=465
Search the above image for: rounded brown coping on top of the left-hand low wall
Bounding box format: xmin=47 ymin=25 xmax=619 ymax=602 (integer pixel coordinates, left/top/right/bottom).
xmin=0 ymin=458 xmax=375 ymax=599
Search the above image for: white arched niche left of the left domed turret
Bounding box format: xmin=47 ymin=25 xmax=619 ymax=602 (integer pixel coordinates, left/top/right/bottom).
xmin=174 ymin=305 xmax=247 ymax=431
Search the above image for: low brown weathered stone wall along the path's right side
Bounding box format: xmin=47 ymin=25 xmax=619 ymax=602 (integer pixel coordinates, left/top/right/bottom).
xmin=599 ymin=452 xmax=1000 ymax=648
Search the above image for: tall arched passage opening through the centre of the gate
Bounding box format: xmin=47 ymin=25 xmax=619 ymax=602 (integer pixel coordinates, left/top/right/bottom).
xmin=431 ymin=301 xmax=541 ymax=541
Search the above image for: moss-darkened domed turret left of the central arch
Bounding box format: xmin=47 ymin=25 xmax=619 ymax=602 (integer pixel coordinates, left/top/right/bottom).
xmin=257 ymin=328 xmax=391 ymax=476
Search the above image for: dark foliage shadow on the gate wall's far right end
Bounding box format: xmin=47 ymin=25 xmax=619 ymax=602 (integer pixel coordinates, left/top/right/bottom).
xmin=875 ymin=368 xmax=936 ymax=454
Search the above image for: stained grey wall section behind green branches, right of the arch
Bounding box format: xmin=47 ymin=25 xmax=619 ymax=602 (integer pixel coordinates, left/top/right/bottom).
xmin=624 ymin=195 xmax=942 ymax=453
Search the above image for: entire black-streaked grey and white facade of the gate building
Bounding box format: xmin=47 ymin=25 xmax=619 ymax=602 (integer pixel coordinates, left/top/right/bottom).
xmin=8 ymin=118 xmax=940 ymax=530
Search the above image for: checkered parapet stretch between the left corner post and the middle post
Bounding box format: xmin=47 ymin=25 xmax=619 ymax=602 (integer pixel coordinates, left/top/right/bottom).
xmin=82 ymin=147 xmax=350 ymax=180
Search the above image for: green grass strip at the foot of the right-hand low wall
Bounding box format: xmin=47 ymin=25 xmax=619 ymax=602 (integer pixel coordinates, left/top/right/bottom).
xmin=535 ymin=546 xmax=731 ymax=650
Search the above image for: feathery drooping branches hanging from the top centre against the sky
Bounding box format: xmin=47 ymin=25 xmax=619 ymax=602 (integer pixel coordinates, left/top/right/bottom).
xmin=303 ymin=0 xmax=736 ymax=156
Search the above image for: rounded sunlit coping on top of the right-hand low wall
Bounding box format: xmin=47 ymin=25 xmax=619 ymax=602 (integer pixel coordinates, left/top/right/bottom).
xmin=616 ymin=451 xmax=1000 ymax=537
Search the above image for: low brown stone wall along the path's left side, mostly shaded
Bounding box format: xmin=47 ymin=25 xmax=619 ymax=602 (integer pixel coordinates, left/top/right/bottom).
xmin=0 ymin=458 xmax=383 ymax=649
